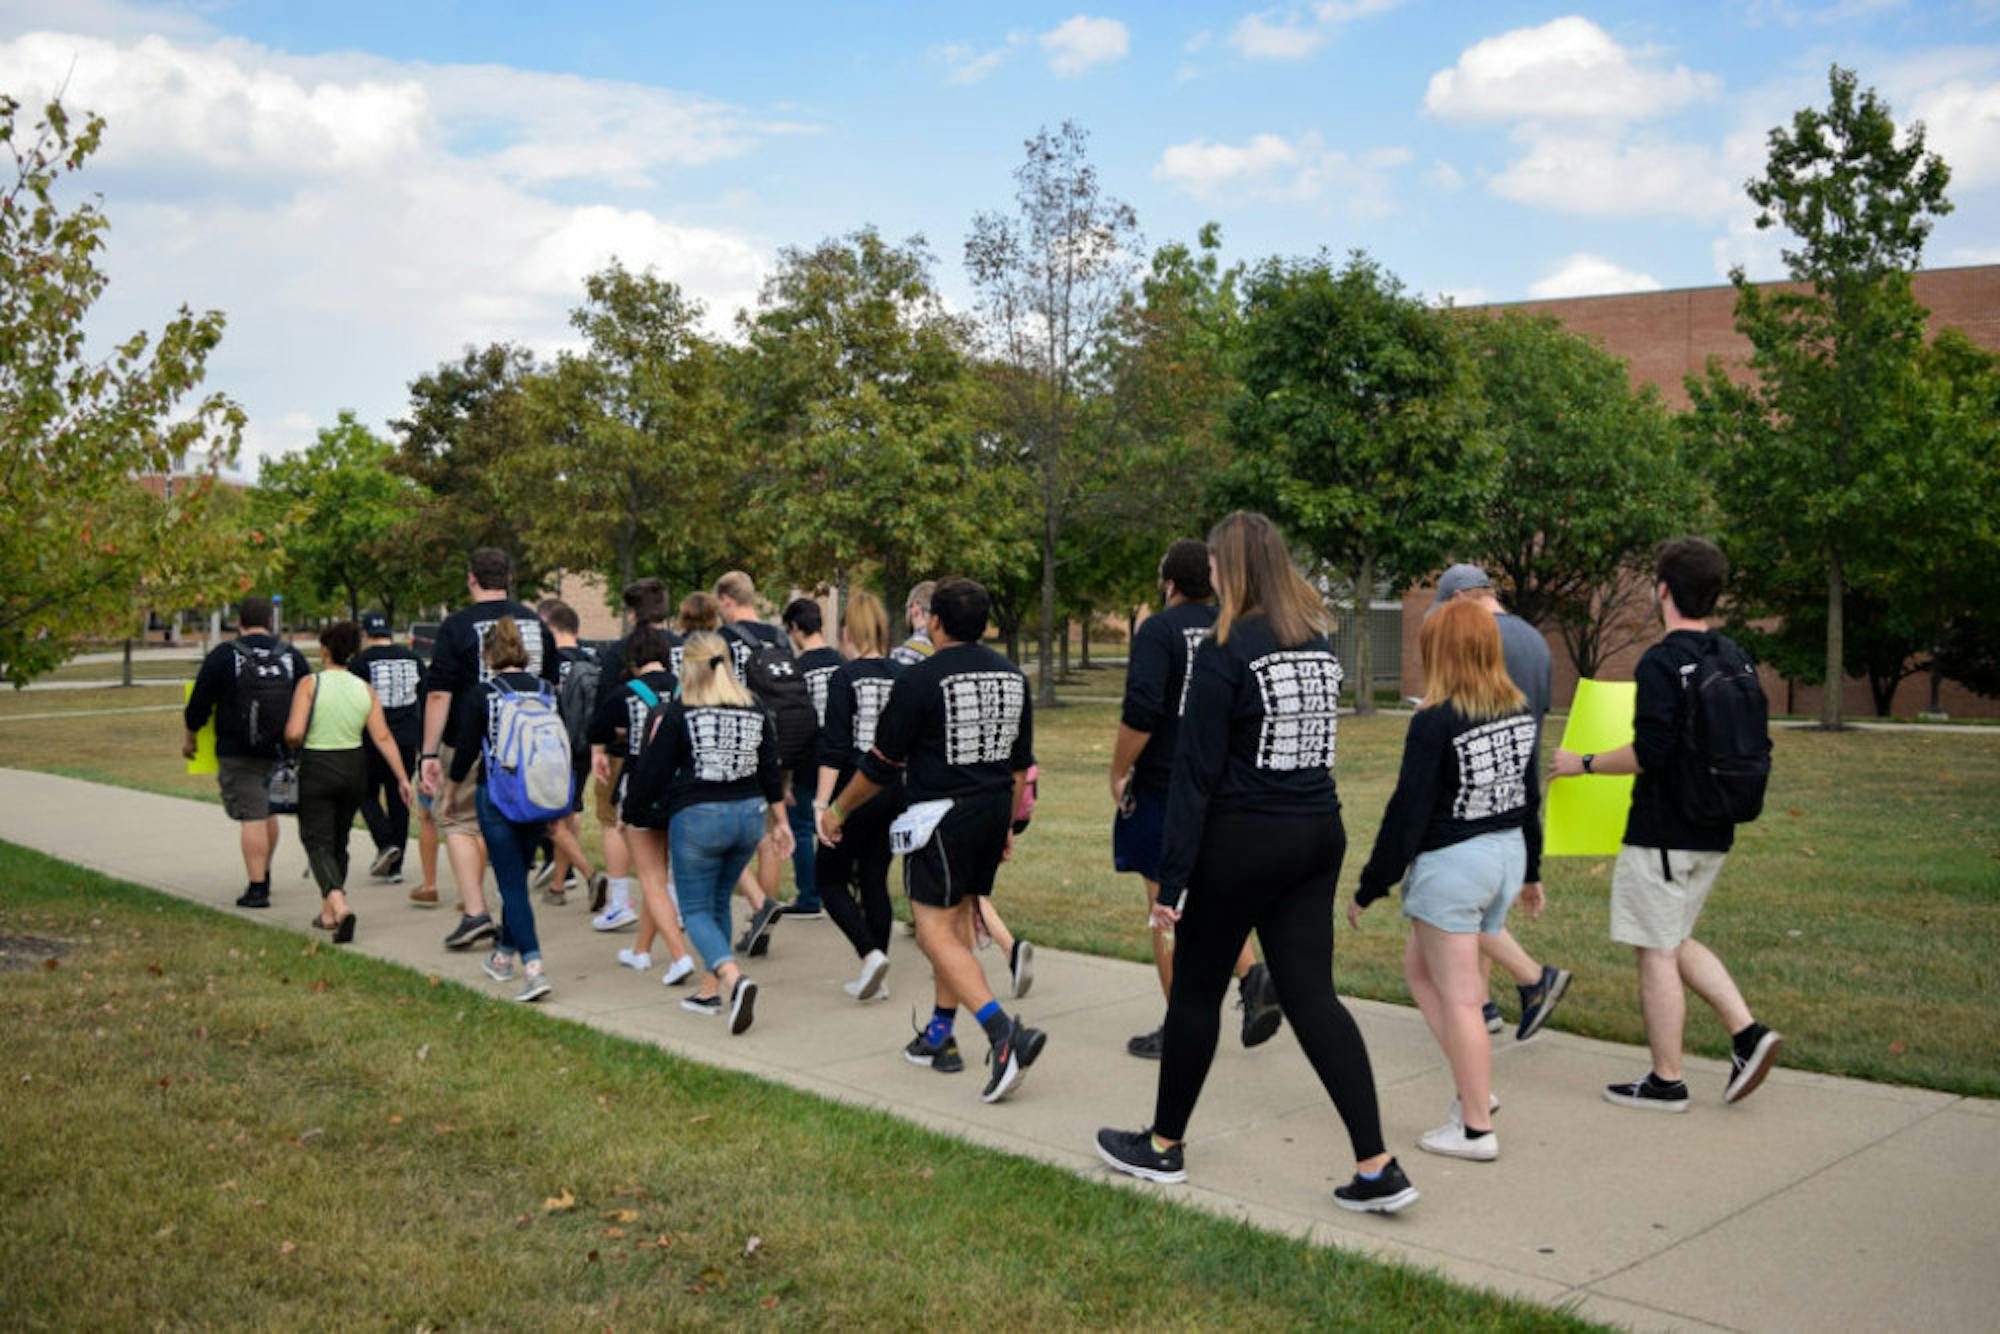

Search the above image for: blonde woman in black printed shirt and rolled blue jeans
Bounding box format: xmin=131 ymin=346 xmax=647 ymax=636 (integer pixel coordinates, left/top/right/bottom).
xmin=626 ymin=630 xmax=792 ymax=1034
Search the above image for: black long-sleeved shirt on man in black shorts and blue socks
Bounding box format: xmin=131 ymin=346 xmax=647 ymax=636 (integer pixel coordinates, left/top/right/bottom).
xmin=862 ymin=644 xmax=1034 ymax=802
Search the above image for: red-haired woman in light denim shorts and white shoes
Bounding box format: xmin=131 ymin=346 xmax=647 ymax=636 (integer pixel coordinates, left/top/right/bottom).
xmin=1348 ymin=602 xmax=1542 ymax=1162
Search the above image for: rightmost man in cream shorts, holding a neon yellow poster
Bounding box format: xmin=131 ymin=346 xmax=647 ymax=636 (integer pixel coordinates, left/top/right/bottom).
xmin=1548 ymin=538 xmax=1784 ymax=1112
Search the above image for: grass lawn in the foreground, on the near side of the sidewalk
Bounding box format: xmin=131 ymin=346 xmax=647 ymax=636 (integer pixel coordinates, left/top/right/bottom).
xmin=0 ymin=844 xmax=1584 ymax=1330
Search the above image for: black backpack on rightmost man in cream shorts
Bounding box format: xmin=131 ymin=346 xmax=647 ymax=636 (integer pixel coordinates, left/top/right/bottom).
xmin=1670 ymin=634 xmax=1770 ymax=824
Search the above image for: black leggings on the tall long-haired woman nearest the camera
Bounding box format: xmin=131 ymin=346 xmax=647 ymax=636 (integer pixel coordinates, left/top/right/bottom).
xmin=1152 ymin=810 xmax=1382 ymax=1160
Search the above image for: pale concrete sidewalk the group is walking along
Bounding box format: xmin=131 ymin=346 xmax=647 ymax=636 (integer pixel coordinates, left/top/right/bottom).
xmin=0 ymin=770 xmax=2000 ymax=1330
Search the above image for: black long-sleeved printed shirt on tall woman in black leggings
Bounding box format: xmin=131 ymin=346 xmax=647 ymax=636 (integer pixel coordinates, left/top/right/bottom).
xmin=1160 ymin=616 xmax=1342 ymax=900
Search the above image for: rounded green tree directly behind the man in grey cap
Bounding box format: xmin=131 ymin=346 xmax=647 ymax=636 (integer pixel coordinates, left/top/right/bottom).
xmin=1462 ymin=312 xmax=1700 ymax=676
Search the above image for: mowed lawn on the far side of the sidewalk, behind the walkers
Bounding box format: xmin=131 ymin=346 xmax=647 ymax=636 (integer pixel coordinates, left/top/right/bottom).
xmin=0 ymin=670 xmax=2000 ymax=1096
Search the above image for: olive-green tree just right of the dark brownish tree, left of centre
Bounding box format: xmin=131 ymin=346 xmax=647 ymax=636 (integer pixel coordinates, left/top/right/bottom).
xmin=502 ymin=260 xmax=744 ymax=586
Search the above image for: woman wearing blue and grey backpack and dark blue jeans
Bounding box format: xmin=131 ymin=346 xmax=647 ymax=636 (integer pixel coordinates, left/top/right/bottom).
xmin=434 ymin=618 xmax=572 ymax=1000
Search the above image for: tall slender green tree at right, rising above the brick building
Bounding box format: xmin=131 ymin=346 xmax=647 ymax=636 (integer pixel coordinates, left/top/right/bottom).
xmin=1688 ymin=66 xmax=1950 ymax=728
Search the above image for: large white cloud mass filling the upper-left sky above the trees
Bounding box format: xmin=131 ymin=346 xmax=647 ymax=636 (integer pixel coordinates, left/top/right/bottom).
xmin=0 ymin=16 xmax=776 ymax=468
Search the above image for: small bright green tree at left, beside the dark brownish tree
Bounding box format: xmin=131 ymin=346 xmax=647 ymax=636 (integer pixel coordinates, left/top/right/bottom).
xmin=256 ymin=412 xmax=438 ymax=620
